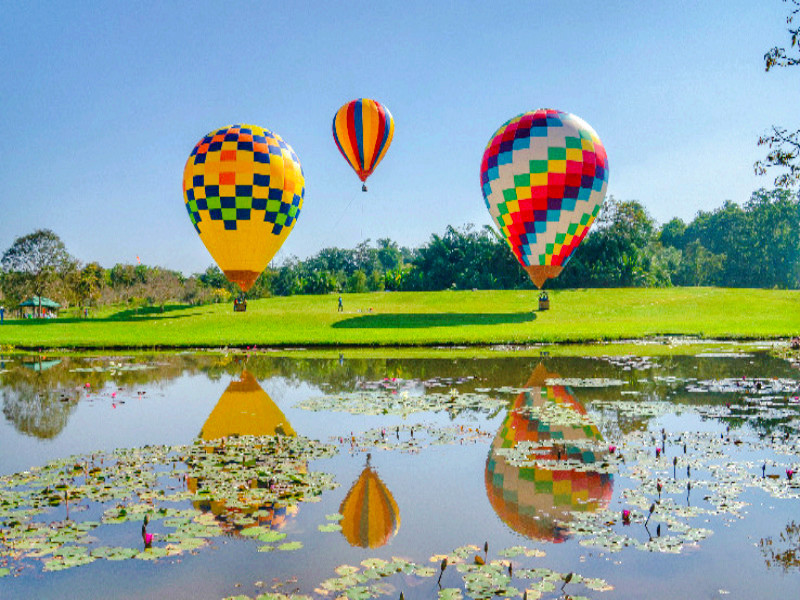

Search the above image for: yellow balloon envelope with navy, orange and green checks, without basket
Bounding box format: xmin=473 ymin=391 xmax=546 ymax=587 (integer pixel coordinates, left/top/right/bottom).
xmin=183 ymin=125 xmax=305 ymax=292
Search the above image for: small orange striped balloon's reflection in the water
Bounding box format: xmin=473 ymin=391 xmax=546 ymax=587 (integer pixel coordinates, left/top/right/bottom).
xmin=339 ymin=455 xmax=400 ymax=548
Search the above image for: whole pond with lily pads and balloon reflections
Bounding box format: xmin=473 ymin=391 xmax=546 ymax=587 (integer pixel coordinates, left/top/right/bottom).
xmin=0 ymin=345 xmax=800 ymax=600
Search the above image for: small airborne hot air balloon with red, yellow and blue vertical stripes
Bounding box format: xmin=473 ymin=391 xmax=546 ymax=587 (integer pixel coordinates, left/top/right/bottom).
xmin=333 ymin=98 xmax=394 ymax=192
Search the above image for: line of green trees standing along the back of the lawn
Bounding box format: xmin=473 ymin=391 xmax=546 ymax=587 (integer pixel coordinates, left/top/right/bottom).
xmin=0 ymin=188 xmax=800 ymax=309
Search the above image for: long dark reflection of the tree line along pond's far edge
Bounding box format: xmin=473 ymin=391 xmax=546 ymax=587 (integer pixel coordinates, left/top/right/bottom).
xmin=0 ymin=350 xmax=796 ymax=437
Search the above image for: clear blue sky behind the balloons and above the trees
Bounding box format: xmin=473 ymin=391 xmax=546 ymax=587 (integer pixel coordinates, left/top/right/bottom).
xmin=0 ymin=0 xmax=800 ymax=274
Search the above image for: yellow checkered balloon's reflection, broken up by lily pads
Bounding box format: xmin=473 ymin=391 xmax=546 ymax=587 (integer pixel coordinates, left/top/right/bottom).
xmin=187 ymin=370 xmax=297 ymax=529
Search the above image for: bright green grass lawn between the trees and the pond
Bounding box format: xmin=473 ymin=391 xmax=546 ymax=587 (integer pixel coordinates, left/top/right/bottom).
xmin=0 ymin=288 xmax=800 ymax=348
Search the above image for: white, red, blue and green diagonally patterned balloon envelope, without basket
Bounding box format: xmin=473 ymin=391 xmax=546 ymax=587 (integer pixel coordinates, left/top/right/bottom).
xmin=481 ymin=109 xmax=608 ymax=288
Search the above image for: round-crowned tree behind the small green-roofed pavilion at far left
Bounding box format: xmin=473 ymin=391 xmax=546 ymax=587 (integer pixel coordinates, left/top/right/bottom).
xmin=0 ymin=229 xmax=78 ymax=316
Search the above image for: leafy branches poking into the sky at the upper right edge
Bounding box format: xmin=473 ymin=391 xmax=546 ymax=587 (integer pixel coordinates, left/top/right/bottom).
xmin=754 ymin=0 xmax=800 ymax=188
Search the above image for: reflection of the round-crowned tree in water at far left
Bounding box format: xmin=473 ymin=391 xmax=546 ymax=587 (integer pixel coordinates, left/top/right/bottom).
xmin=0 ymin=381 xmax=77 ymax=439
